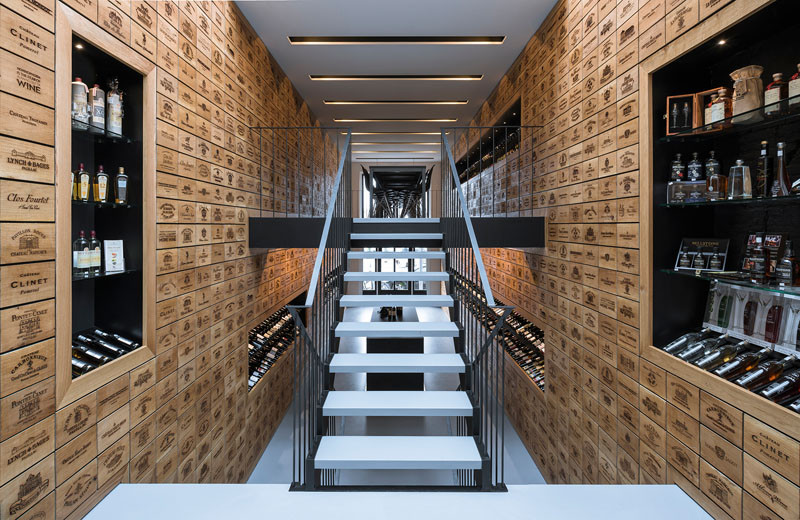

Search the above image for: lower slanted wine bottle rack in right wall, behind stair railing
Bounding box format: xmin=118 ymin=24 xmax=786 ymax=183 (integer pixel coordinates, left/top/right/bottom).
xmin=453 ymin=273 xmax=545 ymax=390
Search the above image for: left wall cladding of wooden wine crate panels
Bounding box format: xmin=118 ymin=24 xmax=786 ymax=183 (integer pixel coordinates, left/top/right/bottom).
xmin=0 ymin=0 xmax=318 ymax=519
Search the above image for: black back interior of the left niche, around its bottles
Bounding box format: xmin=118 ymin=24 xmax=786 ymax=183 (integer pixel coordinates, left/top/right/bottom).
xmin=71 ymin=37 xmax=145 ymax=374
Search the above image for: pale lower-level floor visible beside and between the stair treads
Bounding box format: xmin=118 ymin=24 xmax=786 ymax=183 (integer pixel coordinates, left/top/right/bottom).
xmin=248 ymin=307 xmax=545 ymax=486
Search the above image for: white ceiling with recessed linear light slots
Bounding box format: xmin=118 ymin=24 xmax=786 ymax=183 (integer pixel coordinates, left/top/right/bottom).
xmin=237 ymin=0 xmax=556 ymax=163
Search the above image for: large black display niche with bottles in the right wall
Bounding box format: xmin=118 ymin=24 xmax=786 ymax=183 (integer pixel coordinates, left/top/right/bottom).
xmin=650 ymin=1 xmax=800 ymax=411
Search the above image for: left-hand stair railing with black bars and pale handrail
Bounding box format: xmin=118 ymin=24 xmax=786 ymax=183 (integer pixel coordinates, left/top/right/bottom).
xmin=288 ymin=129 xmax=353 ymax=490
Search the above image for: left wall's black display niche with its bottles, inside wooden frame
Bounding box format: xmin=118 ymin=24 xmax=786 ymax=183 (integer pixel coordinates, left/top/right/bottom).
xmin=70 ymin=37 xmax=143 ymax=379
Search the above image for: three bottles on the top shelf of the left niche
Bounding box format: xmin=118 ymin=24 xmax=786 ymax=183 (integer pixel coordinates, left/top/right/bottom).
xmin=72 ymin=78 xmax=124 ymax=136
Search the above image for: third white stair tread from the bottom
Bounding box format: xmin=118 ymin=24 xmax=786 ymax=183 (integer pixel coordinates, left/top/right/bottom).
xmin=330 ymin=354 xmax=464 ymax=374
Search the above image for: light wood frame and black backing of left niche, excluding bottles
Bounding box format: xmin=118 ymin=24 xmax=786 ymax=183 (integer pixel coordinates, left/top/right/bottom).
xmin=55 ymin=2 xmax=156 ymax=408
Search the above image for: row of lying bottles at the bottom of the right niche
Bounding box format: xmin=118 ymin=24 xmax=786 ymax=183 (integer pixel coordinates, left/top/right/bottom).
xmin=664 ymin=328 xmax=800 ymax=412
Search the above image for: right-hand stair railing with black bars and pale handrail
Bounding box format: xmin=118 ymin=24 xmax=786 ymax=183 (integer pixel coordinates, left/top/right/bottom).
xmin=441 ymin=129 xmax=512 ymax=490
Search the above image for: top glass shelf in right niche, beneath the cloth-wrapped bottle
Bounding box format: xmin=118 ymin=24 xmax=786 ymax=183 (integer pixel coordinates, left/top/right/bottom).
xmin=659 ymin=95 xmax=800 ymax=143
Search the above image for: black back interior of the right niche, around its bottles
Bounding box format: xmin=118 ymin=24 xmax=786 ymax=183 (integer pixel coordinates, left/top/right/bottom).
xmin=643 ymin=0 xmax=800 ymax=347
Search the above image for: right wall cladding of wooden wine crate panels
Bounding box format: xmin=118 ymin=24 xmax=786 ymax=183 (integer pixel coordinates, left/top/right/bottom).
xmin=472 ymin=0 xmax=800 ymax=519
